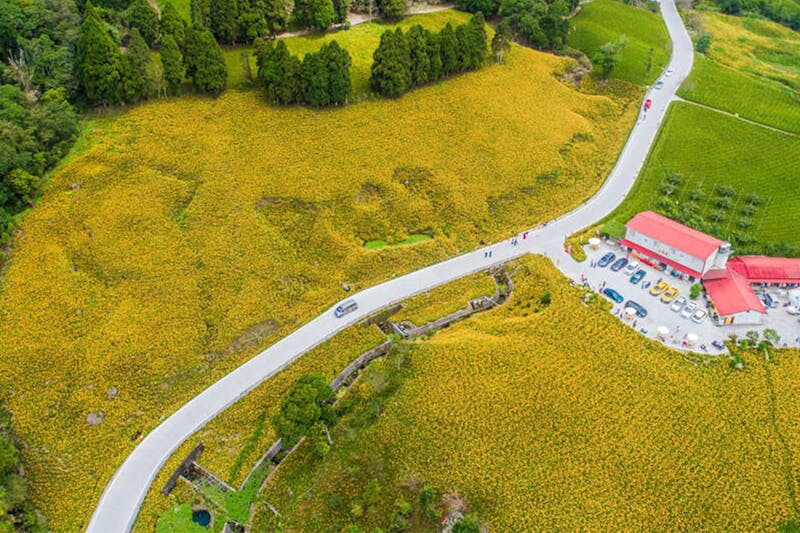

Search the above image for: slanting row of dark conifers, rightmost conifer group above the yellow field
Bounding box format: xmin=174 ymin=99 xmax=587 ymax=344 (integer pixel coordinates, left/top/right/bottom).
xmin=370 ymin=13 xmax=487 ymax=97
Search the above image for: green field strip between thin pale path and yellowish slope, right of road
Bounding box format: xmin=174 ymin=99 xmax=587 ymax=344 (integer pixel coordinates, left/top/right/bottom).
xmin=678 ymin=55 xmax=800 ymax=133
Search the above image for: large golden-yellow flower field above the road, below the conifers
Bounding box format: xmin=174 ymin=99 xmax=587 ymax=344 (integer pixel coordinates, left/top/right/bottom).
xmin=0 ymin=42 xmax=641 ymax=532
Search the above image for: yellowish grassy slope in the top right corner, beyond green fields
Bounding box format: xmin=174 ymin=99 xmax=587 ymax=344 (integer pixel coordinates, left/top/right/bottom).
xmin=701 ymin=12 xmax=800 ymax=91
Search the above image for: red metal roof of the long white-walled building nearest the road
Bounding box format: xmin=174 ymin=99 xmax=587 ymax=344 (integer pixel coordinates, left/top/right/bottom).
xmin=626 ymin=211 xmax=723 ymax=261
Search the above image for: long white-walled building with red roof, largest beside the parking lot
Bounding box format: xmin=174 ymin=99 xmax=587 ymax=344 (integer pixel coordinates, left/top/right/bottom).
xmin=620 ymin=211 xmax=731 ymax=281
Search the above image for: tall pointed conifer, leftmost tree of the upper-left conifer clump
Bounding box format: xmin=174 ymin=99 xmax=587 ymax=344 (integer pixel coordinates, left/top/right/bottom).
xmin=75 ymin=2 xmax=122 ymax=105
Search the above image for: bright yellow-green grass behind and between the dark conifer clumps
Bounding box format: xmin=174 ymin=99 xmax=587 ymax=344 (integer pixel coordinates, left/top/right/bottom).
xmin=225 ymin=9 xmax=478 ymax=92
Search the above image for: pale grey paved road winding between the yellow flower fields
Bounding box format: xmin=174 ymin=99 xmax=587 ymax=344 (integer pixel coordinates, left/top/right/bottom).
xmin=88 ymin=0 xmax=693 ymax=533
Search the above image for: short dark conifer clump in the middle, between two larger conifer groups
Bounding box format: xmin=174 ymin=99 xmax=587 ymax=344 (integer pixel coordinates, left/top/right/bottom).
xmin=256 ymin=40 xmax=351 ymax=107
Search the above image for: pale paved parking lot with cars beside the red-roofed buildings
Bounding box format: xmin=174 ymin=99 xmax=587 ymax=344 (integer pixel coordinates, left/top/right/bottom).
xmin=561 ymin=242 xmax=800 ymax=354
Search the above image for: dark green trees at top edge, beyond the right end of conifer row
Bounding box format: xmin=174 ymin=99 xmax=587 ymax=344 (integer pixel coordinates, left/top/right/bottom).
xmin=456 ymin=0 xmax=579 ymax=50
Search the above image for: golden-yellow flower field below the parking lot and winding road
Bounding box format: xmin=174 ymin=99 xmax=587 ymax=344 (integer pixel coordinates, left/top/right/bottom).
xmin=255 ymin=258 xmax=800 ymax=532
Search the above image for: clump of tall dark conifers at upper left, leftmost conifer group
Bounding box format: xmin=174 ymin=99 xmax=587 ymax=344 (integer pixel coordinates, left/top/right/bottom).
xmin=75 ymin=0 xmax=227 ymax=105
